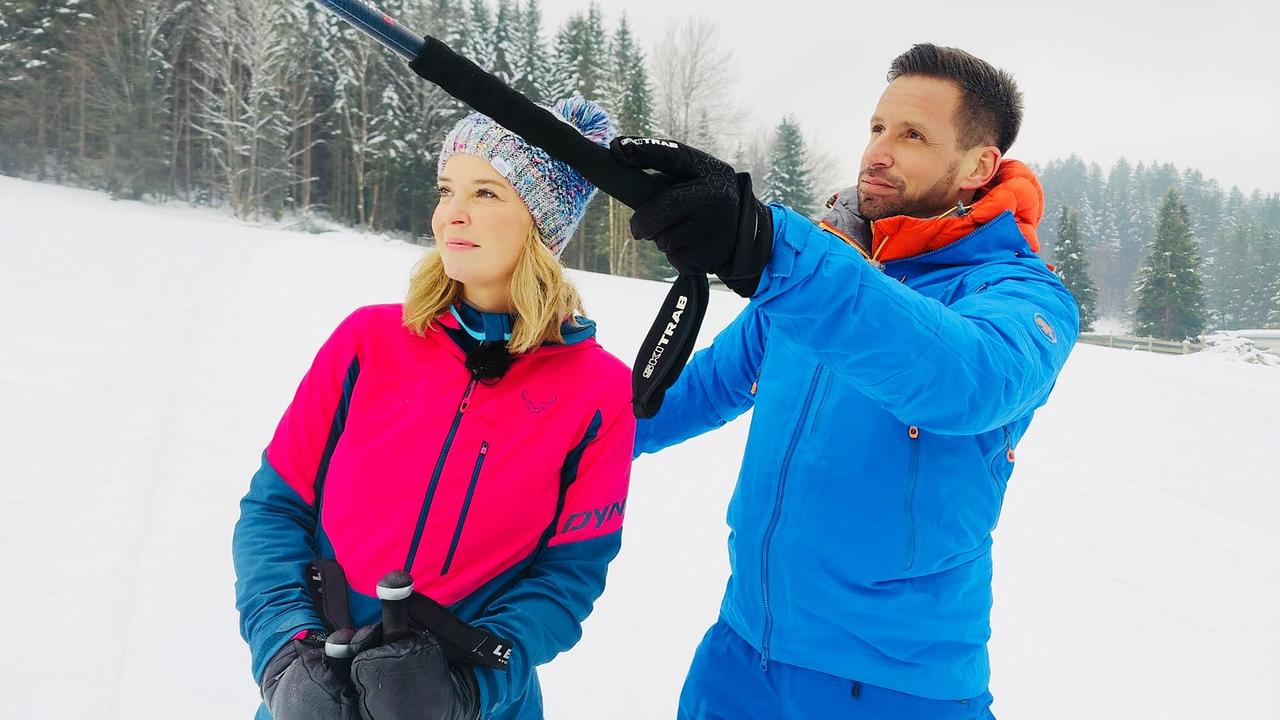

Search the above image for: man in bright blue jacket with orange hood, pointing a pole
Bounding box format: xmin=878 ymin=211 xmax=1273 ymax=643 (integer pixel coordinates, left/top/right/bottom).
xmin=613 ymin=45 xmax=1079 ymax=720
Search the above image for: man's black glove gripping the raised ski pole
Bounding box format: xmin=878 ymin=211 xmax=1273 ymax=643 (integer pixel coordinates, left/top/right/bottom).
xmin=609 ymin=137 xmax=773 ymax=297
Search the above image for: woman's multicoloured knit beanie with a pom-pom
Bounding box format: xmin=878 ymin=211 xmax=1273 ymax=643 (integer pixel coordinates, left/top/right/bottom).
xmin=436 ymin=95 xmax=617 ymax=258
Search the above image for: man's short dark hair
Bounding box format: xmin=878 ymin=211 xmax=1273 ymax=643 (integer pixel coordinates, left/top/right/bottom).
xmin=888 ymin=42 xmax=1023 ymax=154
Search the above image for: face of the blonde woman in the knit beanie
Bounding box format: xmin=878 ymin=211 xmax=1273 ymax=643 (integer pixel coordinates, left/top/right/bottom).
xmin=431 ymin=155 xmax=534 ymax=304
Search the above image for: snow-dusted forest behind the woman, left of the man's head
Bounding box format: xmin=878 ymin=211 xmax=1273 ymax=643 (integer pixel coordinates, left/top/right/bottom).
xmin=0 ymin=0 xmax=814 ymax=278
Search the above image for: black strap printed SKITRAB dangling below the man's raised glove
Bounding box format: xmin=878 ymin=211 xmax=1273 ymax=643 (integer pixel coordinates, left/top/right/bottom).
xmin=631 ymin=274 xmax=710 ymax=419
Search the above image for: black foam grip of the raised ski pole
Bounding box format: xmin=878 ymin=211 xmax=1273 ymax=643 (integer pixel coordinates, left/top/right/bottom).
xmin=410 ymin=36 xmax=664 ymax=209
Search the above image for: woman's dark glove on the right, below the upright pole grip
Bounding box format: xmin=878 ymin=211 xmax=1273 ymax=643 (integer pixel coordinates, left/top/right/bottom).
xmin=351 ymin=624 xmax=480 ymax=720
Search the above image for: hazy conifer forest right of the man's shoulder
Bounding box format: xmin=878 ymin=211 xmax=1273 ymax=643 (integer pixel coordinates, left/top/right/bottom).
xmin=1036 ymin=155 xmax=1280 ymax=340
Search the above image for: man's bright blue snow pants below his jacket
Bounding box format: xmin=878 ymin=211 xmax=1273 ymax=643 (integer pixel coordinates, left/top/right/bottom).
xmin=678 ymin=620 xmax=995 ymax=720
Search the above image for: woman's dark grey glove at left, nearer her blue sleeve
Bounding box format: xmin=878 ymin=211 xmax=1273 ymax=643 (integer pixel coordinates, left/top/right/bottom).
xmin=262 ymin=630 xmax=360 ymax=720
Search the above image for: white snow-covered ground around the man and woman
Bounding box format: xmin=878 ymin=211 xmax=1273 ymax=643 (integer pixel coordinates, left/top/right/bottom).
xmin=0 ymin=178 xmax=1280 ymax=720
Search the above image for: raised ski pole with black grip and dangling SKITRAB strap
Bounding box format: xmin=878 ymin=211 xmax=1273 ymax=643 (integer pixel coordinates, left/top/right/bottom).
xmin=316 ymin=0 xmax=710 ymax=418
